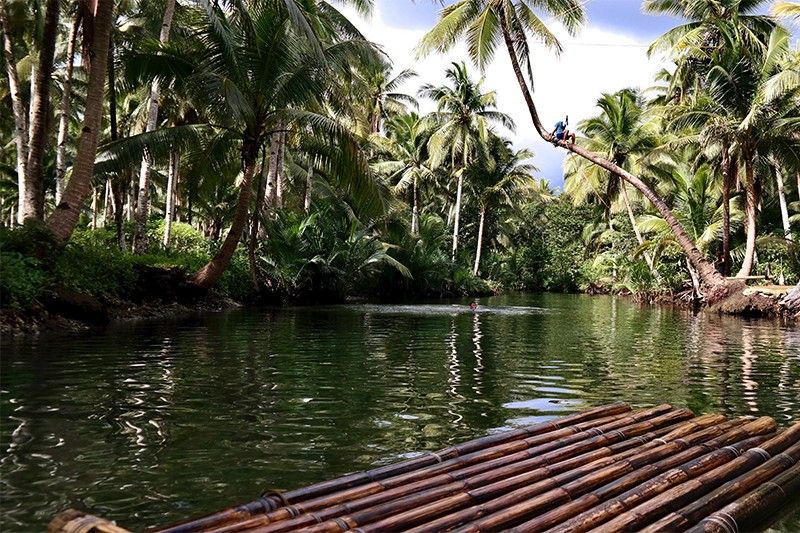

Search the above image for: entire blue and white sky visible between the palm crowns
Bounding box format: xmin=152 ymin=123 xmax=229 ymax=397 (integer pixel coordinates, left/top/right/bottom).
xmin=342 ymin=0 xmax=681 ymax=188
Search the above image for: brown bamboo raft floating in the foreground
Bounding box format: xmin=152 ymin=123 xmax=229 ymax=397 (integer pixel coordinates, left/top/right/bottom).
xmin=49 ymin=403 xmax=800 ymax=533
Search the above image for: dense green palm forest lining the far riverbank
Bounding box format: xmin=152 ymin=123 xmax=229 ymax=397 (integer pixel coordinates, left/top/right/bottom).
xmin=0 ymin=0 xmax=800 ymax=308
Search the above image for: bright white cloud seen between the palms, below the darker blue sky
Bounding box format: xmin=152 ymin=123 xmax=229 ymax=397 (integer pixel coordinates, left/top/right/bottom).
xmin=343 ymin=5 xmax=663 ymax=186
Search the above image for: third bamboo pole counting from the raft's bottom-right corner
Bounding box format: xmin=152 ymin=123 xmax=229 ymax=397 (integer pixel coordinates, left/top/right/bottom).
xmin=580 ymin=424 xmax=800 ymax=533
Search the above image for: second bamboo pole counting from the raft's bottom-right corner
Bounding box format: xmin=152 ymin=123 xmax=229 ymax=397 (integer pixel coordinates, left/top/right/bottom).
xmin=642 ymin=436 xmax=800 ymax=533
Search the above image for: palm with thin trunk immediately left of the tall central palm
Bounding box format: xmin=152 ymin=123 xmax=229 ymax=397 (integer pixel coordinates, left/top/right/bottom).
xmin=373 ymin=112 xmax=431 ymax=235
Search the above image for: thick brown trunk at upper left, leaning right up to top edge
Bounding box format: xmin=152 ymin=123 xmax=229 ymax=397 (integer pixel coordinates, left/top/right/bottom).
xmin=48 ymin=0 xmax=114 ymax=241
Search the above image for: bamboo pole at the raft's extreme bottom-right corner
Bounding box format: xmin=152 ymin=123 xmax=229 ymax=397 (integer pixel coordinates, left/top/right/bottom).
xmin=688 ymin=463 xmax=800 ymax=533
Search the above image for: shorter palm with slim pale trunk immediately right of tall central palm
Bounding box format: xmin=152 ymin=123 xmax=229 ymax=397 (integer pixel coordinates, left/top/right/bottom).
xmin=468 ymin=135 xmax=541 ymax=276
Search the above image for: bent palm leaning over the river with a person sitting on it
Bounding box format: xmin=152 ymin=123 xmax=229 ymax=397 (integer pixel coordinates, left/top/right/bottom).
xmin=419 ymin=0 xmax=725 ymax=290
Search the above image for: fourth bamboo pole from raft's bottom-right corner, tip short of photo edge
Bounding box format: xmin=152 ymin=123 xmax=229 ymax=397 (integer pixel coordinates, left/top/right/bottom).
xmin=514 ymin=419 xmax=775 ymax=532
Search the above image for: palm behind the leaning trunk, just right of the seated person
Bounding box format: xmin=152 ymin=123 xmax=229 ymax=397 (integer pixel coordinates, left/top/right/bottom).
xmin=564 ymin=89 xmax=660 ymax=272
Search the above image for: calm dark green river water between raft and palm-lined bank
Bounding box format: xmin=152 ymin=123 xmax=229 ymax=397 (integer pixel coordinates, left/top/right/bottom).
xmin=0 ymin=295 xmax=800 ymax=532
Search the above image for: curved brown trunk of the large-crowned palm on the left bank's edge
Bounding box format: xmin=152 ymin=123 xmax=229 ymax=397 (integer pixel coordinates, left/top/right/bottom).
xmin=192 ymin=140 xmax=258 ymax=289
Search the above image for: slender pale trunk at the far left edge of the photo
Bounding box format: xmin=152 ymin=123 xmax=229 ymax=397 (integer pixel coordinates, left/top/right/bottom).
xmin=0 ymin=2 xmax=28 ymax=224
